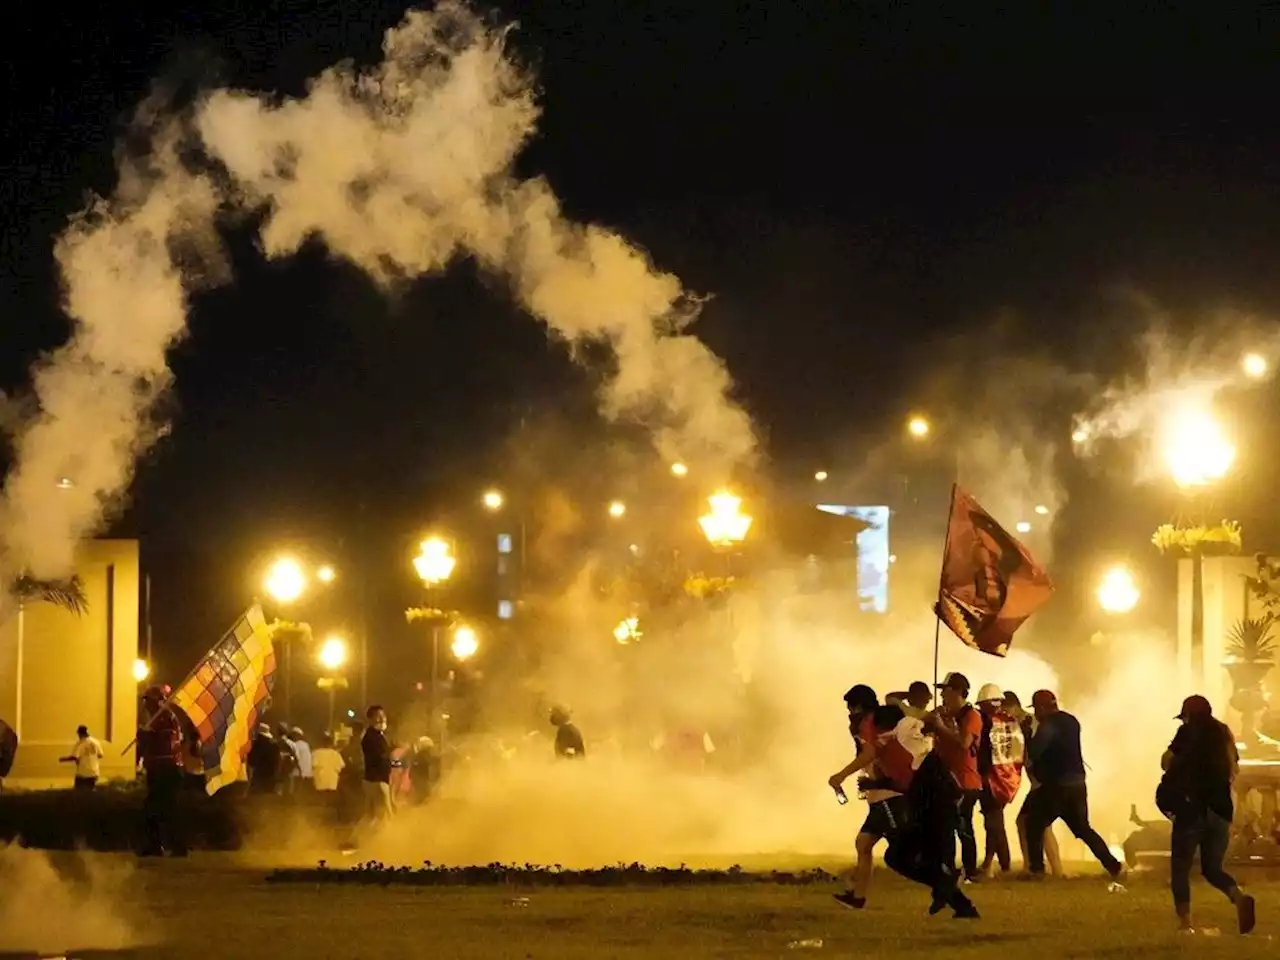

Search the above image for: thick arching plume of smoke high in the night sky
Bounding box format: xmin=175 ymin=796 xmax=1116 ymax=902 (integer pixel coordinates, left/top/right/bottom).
xmin=0 ymin=0 xmax=755 ymax=577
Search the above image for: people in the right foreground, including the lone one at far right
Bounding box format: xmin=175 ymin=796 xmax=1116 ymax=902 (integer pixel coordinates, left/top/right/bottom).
xmin=828 ymin=673 xmax=1256 ymax=933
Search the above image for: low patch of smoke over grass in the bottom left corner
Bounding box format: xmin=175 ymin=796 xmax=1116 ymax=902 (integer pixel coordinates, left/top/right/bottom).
xmin=0 ymin=846 xmax=142 ymax=956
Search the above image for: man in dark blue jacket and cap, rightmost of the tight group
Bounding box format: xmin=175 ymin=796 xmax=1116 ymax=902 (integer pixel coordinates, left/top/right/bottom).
xmin=1027 ymin=690 xmax=1124 ymax=883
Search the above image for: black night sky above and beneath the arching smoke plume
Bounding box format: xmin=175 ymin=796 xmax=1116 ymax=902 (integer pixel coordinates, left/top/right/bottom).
xmin=0 ymin=0 xmax=1280 ymax=711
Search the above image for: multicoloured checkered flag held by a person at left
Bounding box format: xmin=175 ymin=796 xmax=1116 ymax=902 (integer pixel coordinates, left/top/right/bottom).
xmin=169 ymin=604 xmax=275 ymax=795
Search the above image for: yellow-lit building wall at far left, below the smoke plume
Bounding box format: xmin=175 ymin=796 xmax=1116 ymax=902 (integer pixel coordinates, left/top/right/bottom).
xmin=0 ymin=540 xmax=140 ymax=787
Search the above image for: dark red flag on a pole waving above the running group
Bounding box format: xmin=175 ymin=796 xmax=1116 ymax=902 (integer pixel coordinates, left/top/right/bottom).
xmin=936 ymin=486 xmax=1053 ymax=657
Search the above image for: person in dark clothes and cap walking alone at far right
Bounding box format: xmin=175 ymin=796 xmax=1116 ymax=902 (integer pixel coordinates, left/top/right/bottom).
xmin=1156 ymin=696 xmax=1256 ymax=933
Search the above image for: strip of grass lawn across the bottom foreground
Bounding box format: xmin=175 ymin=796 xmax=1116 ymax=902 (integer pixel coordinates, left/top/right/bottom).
xmin=0 ymin=852 xmax=1280 ymax=960
